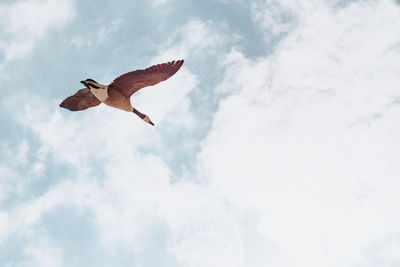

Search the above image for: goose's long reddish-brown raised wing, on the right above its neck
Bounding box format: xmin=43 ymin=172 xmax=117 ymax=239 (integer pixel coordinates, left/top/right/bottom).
xmin=109 ymin=60 xmax=183 ymax=96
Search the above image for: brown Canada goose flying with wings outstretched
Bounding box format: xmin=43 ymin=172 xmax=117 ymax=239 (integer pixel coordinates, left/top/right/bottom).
xmin=60 ymin=59 xmax=184 ymax=126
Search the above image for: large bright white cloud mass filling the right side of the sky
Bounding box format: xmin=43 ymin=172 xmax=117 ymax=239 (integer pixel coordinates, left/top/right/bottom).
xmin=199 ymin=1 xmax=400 ymax=266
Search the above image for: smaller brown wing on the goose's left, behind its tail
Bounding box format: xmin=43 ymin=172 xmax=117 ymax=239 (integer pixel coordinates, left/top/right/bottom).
xmin=60 ymin=88 xmax=101 ymax=111
